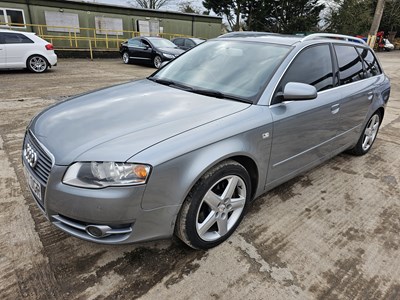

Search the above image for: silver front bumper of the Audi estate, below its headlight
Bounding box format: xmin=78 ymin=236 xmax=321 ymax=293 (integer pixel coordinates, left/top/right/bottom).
xmin=22 ymin=131 xmax=179 ymax=244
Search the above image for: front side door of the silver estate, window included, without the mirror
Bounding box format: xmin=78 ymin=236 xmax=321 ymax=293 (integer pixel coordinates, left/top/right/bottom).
xmin=267 ymin=44 xmax=340 ymax=185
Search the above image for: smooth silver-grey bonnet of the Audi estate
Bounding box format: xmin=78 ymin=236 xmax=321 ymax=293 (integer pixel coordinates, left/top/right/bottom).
xmin=30 ymin=79 xmax=250 ymax=165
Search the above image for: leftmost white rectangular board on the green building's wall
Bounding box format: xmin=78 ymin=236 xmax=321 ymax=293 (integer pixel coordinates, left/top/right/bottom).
xmin=44 ymin=11 xmax=80 ymax=32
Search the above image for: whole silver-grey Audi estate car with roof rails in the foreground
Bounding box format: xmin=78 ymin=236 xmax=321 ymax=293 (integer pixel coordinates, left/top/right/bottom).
xmin=22 ymin=34 xmax=390 ymax=249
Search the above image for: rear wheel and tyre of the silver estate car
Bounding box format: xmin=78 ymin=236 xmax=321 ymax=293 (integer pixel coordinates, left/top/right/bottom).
xmin=348 ymin=111 xmax=382 ymax=156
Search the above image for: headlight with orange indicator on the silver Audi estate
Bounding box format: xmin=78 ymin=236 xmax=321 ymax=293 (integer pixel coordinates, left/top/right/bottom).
xmin=63 ymin=162 xmax=151 ymax=188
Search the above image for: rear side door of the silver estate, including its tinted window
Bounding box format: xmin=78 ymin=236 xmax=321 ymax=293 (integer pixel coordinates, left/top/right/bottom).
xmin=334 ymin=44 xmax=379 ymax=147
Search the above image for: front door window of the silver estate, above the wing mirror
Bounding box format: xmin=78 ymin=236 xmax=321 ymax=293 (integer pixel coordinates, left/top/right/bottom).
xmin=278 ymin=45 xmax=333 ymax=91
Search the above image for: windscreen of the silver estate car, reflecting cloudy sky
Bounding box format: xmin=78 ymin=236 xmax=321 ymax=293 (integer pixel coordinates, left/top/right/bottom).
xmin=152 ymin=40 xmax=291 ymax=102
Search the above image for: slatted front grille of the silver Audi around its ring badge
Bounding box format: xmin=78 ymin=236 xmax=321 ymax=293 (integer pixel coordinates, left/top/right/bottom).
xmin=24 ymin=131 xmax=53 ymax=186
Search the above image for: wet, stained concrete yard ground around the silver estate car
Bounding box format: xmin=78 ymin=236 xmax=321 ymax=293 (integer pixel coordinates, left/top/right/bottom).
xmin=0 ymin=51 xmax=400 ymax=299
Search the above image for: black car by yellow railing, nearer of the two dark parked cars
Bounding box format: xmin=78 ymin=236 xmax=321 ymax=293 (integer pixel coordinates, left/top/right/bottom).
xmin=119 ymin=37 xmax=184 ymax=69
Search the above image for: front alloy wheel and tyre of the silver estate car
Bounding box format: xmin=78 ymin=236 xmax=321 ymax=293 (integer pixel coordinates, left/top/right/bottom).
xmin=175 ymin=160 xmax=251 ymax=249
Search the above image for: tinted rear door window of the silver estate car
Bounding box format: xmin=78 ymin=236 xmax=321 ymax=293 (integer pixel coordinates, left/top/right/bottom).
xmin=335 ymin=45 xmax=364 ymax=84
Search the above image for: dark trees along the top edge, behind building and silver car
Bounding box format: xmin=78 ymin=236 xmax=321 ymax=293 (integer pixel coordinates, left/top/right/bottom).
xmin=128 ymin=0 xmax=400 ymax=35
